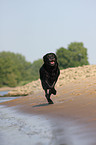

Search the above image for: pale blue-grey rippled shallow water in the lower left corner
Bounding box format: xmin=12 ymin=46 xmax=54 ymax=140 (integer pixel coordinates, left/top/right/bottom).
xmin=0 ymin=106 xmax=52 ymax=145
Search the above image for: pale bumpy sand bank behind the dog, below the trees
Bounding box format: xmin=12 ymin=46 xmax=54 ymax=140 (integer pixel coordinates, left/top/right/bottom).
xmin=8 ymin=65 xmax=96 ymax=96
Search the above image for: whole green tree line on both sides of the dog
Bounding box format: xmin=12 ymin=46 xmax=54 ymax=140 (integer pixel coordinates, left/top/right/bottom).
xmin=0 ymin=42 xmax=89 ymax=87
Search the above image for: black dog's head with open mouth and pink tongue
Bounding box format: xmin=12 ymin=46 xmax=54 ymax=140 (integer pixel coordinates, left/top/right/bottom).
xmin=43 ymin=53 xmax=57 ymax=66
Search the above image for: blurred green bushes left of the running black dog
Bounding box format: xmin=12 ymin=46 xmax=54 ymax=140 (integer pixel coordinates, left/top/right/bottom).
xmin=0 ymin=52 xmax=42 ymax=87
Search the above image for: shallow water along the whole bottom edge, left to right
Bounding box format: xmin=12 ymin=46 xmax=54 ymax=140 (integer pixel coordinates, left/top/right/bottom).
xmin=0 ymin=106 xmax=96 ymax=145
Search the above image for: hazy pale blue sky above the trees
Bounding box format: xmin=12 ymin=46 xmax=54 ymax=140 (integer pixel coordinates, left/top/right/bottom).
xmin=0 ymin=0 xmax=96 ymax=64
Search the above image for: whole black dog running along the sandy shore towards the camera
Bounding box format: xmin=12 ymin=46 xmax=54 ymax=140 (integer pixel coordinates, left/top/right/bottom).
xmin=39 ymin=53 xmax=60 ymax=104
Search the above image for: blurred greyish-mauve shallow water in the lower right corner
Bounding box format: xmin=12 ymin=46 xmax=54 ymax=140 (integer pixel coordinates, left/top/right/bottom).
xmin=52 ymin=120 xmax=96 ymax=145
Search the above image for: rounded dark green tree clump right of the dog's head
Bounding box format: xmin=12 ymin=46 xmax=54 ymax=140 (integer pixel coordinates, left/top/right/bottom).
xmin=56 ymin=42 xmax=89 ymax=69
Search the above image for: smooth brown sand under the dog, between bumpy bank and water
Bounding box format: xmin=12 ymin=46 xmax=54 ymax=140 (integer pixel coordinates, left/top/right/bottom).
xmin=0 ymin=78 xmax=96 ymax=123
